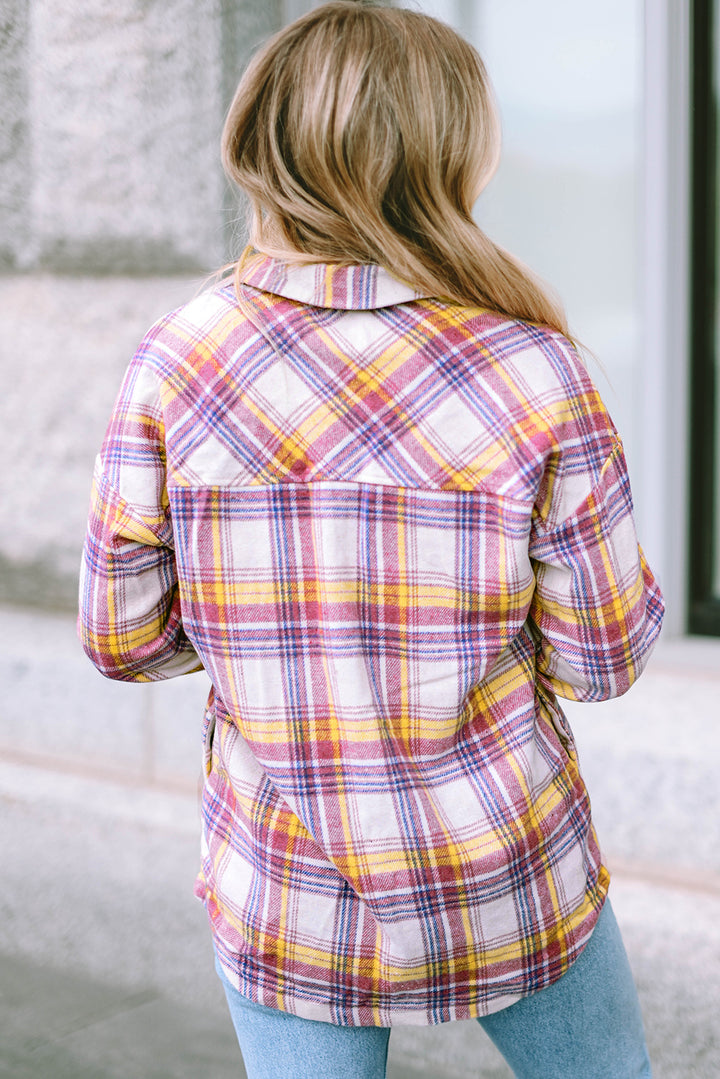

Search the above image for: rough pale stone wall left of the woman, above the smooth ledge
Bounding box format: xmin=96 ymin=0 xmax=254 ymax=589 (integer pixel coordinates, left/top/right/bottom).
xmin=0 ymin=0 xmax=285 ymax=609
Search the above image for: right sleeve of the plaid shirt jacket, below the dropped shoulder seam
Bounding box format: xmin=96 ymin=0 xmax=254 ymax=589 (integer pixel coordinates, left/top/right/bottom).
xmin=529 ymin=433 xmax=664 ymax=700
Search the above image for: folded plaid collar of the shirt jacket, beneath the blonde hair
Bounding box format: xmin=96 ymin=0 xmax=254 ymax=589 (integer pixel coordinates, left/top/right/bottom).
xmin=240 ymin=252 xmax=426 ymax=311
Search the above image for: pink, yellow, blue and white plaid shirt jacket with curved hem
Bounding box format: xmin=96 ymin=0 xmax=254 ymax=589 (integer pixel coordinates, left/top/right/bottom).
xmin=80 ymin=248 xmax=663 ymax=1026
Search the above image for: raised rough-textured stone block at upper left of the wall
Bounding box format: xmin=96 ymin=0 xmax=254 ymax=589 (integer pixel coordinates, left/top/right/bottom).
xmin=27 ymin=0 xmax=222 ymax=273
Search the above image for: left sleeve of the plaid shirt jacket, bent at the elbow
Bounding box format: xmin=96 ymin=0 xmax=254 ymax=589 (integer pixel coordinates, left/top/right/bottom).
xmin=78 ymin=347 xmax=202 ymax=682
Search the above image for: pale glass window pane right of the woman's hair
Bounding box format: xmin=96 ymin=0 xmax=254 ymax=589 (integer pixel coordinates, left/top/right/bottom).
xmin=399 ymin=0 xmax=642 ymax=472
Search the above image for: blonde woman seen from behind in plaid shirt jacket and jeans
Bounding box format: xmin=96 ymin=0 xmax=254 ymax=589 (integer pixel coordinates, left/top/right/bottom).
xmin=81 ymin=2 xmax=663 ymax=1079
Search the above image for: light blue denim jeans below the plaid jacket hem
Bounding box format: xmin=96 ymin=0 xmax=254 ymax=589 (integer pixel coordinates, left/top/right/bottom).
xmin=215 ymin=901 xmax=651 ymax=1079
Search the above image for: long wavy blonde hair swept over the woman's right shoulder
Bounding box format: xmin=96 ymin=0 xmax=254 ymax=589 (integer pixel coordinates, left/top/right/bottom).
xmin=222 ymin=0 xmax=567 ymax=333
